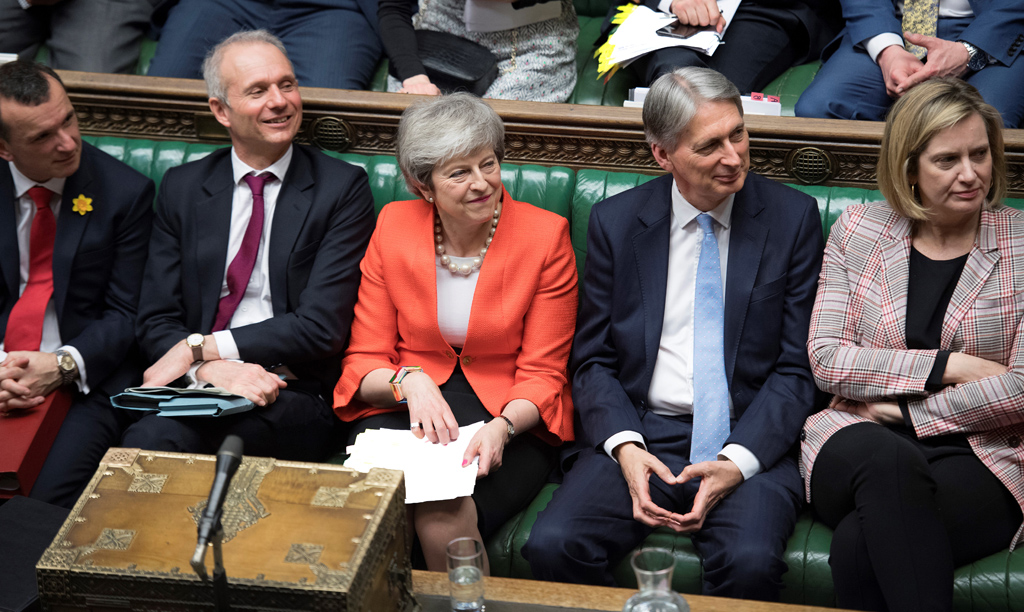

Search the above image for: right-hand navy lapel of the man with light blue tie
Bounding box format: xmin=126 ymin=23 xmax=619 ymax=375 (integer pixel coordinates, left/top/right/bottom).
xmin=724 ymin=184 xmax=768 ymax=383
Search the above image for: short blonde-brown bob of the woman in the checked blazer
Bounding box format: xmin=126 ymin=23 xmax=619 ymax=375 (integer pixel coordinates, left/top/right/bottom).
xmin=878 ymin=78 xmax=1007 ymax=221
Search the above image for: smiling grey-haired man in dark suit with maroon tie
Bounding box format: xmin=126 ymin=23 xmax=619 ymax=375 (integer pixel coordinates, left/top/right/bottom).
xmin=122 ymin=31 xmax=374 ymax=461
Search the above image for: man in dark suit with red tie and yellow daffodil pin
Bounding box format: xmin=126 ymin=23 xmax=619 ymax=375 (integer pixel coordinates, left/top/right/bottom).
xmin=0 ymin=61 xmax=154 ymax=505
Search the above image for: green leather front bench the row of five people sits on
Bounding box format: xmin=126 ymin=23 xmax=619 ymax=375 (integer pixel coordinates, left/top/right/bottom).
xmin=85 ymin=137 xmax=1024 ymax=612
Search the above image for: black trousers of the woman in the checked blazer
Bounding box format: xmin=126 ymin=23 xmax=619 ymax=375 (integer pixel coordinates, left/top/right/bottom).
xmin=811 ymin=423 xmax=1022 ymax=612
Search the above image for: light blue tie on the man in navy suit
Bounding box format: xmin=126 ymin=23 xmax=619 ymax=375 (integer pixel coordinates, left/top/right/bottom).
xmin=690 ymin=213 xmax=729 ymax=464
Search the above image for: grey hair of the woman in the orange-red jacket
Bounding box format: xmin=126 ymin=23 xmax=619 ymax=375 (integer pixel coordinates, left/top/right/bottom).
xmin=394 ymin=92 xmax=505 ymax=193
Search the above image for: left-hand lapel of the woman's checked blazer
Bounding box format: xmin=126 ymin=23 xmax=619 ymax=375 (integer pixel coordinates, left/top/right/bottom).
xmin=879 ymin=215 xmax=910 ymax=349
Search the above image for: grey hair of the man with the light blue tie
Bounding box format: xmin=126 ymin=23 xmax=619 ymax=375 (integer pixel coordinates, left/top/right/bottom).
xmin=643 ymin=67 xmax=743 ymax=150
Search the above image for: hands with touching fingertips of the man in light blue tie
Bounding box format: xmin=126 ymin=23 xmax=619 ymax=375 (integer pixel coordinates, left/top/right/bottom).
xmin=615 ymin=443 xmax=743 ymax=533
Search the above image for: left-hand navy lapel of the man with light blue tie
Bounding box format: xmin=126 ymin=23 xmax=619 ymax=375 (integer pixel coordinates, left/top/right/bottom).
xmin=633 ymin=180 xmax=674 ymax=388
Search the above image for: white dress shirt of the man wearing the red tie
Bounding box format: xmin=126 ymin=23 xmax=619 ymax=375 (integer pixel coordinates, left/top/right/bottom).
xmin=0 ymin=162 xmax=89 ymax=393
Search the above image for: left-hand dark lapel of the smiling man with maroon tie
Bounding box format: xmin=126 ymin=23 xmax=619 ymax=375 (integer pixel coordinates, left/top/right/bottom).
xmin=196 ymin=154 xmax=233 ymax=330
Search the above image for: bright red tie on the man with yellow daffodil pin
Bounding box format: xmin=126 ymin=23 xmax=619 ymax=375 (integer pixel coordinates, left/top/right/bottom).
xmin=4 ymin=185 xmax=57 ymax=351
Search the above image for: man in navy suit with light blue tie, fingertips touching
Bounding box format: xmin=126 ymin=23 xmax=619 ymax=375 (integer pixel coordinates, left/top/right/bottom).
xmin=523 ymin=68 xmax=824 ymax=600
